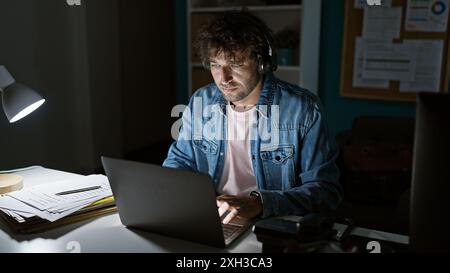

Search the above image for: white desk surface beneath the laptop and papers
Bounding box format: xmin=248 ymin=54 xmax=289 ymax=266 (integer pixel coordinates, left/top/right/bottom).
xmin=0 ymin=167 xmax=408 ymax=253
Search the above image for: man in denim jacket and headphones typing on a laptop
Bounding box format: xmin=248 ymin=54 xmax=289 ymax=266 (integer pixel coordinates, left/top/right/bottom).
xmin=163 ymin=12 xmax=342 ymax=224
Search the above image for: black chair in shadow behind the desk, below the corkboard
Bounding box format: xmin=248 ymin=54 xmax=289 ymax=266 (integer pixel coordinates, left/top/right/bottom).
xmin=337 ymin=117 xmax=414 ymax=234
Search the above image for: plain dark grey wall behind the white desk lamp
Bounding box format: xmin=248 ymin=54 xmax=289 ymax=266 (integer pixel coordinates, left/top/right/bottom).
xmin=0 ymin=0 xmax=122 ymax=173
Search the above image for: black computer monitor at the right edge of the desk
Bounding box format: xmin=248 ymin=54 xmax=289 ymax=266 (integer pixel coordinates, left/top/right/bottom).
xmin=409 ymin=94 xmax=450 ymax=252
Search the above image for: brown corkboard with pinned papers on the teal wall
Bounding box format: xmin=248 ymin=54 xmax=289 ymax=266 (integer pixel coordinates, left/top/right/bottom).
xmin=340 ymin=0 xmax=450 ymax=102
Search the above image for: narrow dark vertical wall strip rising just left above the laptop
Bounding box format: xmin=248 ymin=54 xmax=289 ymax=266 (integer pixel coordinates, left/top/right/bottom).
xmin=85 ymin=0 xmax=125 ymax=169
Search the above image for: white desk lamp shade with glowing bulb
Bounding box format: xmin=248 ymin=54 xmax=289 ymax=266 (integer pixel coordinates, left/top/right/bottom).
xmin=0 ymin=66 xmax=45 ymax=123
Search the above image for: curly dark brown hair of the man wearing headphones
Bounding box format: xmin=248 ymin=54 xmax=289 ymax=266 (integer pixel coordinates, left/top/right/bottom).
xmin=194 ymin=11 xmax=274 ymax=68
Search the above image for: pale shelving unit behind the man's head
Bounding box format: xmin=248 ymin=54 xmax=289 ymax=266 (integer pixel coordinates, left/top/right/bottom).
xmin=186 ymin=0 xmax=322 ymax=94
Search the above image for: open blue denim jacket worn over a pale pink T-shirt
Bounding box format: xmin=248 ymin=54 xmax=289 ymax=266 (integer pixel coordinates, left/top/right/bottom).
xmin=163 ymin=74 xmax=342 ymax=217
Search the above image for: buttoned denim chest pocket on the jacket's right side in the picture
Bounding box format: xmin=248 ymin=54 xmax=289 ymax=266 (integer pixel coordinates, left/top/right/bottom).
xmin=260 ymin=145 xmax=295 ymax=190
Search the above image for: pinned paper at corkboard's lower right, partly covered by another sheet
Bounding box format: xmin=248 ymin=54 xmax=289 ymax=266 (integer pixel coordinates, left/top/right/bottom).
xmin=400 ymin=40 xmax=444 ymax=92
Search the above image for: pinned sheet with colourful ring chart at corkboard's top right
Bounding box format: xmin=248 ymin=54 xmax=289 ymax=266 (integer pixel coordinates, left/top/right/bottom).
xmin=405 ymin=0 xmax=449 ymax=32
